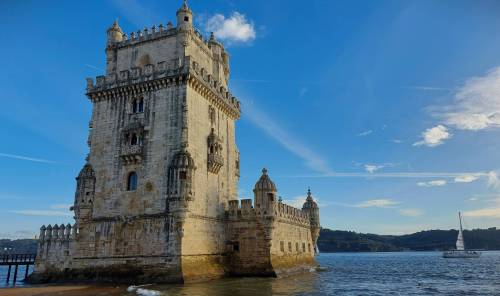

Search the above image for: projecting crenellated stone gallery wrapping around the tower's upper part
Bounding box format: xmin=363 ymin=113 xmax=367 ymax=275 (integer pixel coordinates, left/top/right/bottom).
xmin=87 ymin=57 xmax=241 ymax=119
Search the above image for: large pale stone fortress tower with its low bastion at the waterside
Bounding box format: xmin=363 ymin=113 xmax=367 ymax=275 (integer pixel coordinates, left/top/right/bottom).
xmin=31 ymin=3 xmax=320 ymax=282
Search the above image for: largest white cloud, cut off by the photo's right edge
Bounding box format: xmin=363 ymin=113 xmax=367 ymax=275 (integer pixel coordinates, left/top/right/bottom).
xmin=435 ymin=67 xmax=500 ymax=131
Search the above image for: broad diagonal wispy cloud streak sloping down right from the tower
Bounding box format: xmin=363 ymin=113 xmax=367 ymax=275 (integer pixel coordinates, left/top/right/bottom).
xmin=241 ymin=98 xmax=333 ymax=174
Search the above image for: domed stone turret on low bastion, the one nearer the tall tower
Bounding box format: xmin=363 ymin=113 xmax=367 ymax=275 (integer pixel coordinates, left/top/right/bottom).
xmin=253 ymin=168 xmax=278 ymax=216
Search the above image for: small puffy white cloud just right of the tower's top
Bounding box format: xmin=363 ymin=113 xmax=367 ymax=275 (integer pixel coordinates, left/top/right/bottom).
xmin=206 ymin=12 xmax=256 ymax=43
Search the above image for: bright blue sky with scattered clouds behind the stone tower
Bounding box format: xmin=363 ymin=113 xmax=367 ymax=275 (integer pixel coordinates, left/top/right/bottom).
xmin=0 ymin=0 xmax=500 ymax=237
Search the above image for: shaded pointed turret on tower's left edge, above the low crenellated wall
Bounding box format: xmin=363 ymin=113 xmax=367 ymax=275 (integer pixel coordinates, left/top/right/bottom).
xmin=72 ymin=163 xmax=96 ymax=221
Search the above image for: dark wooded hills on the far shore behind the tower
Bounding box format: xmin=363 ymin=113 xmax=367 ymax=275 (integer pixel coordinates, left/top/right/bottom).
xmin=0 ymin=228 xmax=500 ymax=254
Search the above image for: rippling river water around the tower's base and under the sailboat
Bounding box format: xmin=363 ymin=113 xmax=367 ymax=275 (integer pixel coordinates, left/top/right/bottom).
xmin=0 ymin=252 xmax=500 ymax=296
